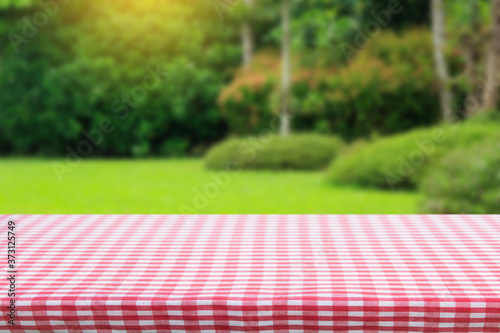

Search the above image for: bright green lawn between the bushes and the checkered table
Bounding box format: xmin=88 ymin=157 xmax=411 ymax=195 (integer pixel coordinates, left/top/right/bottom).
xmin=0 ymin=159 xmax=419 ymax=214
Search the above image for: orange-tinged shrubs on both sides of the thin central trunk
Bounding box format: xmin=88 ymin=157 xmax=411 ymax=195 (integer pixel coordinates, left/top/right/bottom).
xmin=219 ymin=30 xmax=439 ymax=139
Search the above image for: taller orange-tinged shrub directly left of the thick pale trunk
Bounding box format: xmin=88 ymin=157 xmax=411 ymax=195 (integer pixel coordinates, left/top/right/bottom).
xmin=324 ymin=30 xmax=439 ymax=139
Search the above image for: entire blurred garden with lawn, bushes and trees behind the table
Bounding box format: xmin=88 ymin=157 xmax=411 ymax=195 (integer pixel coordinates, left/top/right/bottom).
xmin=0 ymin=0 xmax=500 ymax=214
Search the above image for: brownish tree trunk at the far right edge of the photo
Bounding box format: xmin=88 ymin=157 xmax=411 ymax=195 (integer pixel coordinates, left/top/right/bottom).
xmin=482 ymin=0 xmax=500 ymax=110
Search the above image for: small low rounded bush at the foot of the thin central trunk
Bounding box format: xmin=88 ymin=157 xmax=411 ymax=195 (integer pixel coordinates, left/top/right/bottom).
xmin=205 ymin=134 xmax=343 ymax=170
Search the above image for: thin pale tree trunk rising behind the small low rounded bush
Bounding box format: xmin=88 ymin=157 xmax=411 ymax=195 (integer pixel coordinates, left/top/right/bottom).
xmin=281 ymin=0 xmax=291 ymax=136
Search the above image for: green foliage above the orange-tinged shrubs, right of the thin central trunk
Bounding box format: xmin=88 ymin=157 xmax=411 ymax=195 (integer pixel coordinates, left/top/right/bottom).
xmin=270 ymin=0 xmax=430 ymax=63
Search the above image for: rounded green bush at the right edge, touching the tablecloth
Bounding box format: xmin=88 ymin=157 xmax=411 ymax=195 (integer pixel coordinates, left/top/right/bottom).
xmin=420 ymin=140 xmax=500 ymax=214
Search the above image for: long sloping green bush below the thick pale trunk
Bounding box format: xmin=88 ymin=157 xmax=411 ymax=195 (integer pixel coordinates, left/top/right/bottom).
xmin=328 ymin=122 xmax=500 ymax=189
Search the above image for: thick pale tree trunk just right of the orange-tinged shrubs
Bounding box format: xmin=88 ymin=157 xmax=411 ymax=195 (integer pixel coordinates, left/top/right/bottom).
xmin=431 ymin=0 xmax=454 ymax=122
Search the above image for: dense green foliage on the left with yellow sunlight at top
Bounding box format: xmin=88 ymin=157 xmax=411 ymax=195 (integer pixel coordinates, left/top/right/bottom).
xmin=0 ymin=0 xmax=240 ymax=156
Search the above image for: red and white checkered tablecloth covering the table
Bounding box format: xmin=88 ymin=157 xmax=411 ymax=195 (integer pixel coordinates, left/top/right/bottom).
xmin=0 ymin=215 xmax=500 ymax=332
